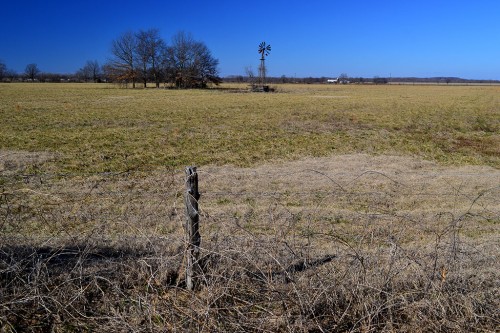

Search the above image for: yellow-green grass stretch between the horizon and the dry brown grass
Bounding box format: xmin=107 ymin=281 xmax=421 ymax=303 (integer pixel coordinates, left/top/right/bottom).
xmin=0 ymin=84 xmax=500 ymax=172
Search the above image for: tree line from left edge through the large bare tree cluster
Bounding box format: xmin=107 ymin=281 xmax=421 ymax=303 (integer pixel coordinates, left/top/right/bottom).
xmin=0 ymin=29 xmax=222 ymax=88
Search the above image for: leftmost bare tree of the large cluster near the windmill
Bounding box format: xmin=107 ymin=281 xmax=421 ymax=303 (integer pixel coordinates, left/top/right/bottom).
xmin=106 ymin=31 xmax=137 ymax=88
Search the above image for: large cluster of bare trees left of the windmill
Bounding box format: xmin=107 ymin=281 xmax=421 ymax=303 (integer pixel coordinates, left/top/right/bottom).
xmin=103 ymin=29 xmax=221 ymax=88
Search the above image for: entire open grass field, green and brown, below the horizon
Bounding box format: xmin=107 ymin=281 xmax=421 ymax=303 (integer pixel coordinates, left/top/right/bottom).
xmin=0 ymin=84 xmax=500 ymax=332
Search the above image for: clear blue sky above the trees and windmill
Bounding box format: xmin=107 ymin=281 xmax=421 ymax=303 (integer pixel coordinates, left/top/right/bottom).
xmin=0 ymin=0 xmax=500 ymax=80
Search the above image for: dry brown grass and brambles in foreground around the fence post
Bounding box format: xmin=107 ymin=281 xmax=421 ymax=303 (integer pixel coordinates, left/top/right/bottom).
xmin=0 ymin=152 xmax=500 ymax=332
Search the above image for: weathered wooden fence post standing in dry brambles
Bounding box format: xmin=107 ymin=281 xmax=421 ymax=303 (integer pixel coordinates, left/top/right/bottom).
xmin=184 ymin=166 xmax=201 ymax=290
